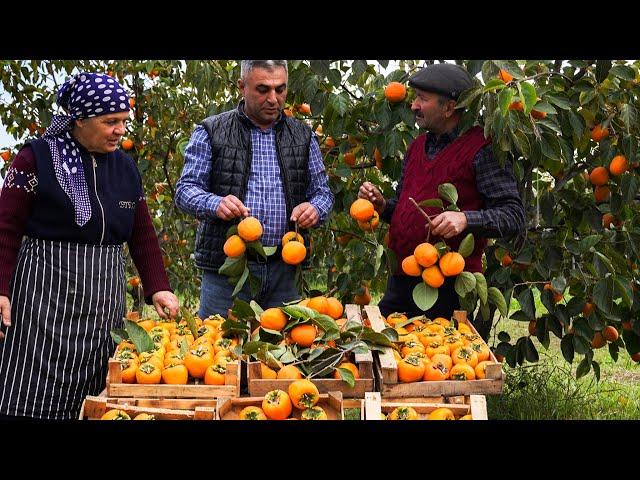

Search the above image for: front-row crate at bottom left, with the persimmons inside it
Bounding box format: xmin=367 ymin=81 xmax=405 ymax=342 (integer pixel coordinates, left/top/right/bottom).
xmin=79 ymin=395 xmax=216 ymax=420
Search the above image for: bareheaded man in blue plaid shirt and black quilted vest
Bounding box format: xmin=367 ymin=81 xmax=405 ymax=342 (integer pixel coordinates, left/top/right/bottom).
xmin=175 ymin=60 xmax=334 ymax=318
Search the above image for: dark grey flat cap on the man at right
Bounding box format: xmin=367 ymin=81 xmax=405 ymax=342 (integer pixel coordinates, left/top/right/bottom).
xmin=409 ymin=63 xmax=473 ymax=100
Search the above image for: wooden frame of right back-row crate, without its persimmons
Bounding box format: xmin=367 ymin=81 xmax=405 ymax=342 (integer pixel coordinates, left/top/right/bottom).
xmin=364 ymin=305 xmax=504 ymax=398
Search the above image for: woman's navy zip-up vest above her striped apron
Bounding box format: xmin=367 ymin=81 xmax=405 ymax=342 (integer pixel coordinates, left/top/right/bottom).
xmin=25 ymin=139 xmax=142 ymax=245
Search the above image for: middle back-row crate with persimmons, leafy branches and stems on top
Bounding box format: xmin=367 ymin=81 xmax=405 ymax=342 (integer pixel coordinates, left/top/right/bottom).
xmin=220 ymin=296 xmax=391 ymax=398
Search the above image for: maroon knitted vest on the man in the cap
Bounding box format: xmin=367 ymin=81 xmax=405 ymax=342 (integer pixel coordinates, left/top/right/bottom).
xmin=389 ymin=127 xmax=491 ymax=275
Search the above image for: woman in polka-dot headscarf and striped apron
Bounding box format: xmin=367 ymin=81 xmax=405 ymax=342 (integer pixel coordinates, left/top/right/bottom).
xmin=0 ymin=73 xmax=178 ymax=419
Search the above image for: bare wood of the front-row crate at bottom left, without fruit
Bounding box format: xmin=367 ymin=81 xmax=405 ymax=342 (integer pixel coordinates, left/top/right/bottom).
xmin=79 ymin=396 xmax=216 ymax=420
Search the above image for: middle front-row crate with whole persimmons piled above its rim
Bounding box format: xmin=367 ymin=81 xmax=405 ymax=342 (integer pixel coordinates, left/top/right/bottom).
xmin=216 ymin=379 xmax=344 ymax=420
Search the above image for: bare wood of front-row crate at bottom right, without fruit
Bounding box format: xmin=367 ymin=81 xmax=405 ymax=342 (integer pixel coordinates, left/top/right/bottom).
xmin=364 ymin=392 xmax=487 ymax=420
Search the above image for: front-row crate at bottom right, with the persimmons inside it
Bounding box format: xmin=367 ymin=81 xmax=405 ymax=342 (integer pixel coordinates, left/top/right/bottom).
xmin=364 ymin=392 xmax=487 ymax=420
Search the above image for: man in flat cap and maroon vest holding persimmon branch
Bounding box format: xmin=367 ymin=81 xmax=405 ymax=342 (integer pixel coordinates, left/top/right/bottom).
xmin=358 ymin=63 xmax=525 ymax=339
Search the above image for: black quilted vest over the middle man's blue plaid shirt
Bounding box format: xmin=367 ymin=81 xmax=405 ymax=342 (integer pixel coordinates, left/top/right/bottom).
xmin=195 ymin=102 xmax=311 ymax=270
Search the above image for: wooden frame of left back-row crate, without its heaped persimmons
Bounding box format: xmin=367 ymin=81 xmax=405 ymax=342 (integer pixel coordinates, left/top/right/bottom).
xmin=107 ymin=358 xmax=240 ymax=399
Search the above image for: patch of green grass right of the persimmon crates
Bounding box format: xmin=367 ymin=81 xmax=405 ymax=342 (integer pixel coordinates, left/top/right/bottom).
xmin=487 ymin=288 xmax=640 ymax=420
